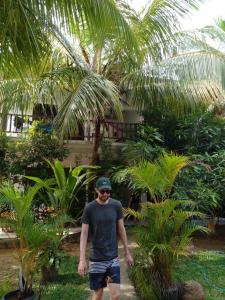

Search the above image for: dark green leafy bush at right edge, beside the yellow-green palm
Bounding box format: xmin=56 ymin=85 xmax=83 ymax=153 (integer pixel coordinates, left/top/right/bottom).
xmin=173 ymin=150 xmax=225 ymax=216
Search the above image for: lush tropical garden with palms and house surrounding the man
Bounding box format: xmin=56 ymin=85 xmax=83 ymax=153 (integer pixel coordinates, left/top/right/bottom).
xmin=0 ymin=0 xmax=225 ymax=300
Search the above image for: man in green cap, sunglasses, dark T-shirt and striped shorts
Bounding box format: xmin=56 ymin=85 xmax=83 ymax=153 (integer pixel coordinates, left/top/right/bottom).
xmin=78 ymin=177 xmax=134 ymax=300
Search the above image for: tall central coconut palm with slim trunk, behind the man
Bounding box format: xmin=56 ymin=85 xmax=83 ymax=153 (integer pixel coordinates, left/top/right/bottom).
xmin=0 ymin=0 xmax=206 ymax=162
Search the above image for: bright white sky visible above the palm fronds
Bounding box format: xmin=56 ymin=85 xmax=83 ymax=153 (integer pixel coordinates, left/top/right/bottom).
xmin=127 ymin=0 xmax=225 ymax=30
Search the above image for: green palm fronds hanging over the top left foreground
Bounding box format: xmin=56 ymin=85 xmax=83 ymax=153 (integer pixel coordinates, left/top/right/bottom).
xmin=0 ymin=0 xmax=137 ymax=68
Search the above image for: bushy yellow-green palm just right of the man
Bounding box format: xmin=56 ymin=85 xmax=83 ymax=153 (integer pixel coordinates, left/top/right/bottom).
xmin=115 ymin=153 xmax=206 ymax=298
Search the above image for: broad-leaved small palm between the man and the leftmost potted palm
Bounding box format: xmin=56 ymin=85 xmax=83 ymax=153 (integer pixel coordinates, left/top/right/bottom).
xmin=26 ymin=160 xmax=95 ymax=284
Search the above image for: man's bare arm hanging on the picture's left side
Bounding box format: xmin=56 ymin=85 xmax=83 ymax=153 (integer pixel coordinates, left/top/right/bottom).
xmin=78 ymin=224 xmax=89 ymax=277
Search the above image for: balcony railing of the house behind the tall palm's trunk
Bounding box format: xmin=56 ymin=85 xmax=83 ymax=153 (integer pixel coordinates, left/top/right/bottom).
xmin=0 ymin=114 xmax=138 ymax=142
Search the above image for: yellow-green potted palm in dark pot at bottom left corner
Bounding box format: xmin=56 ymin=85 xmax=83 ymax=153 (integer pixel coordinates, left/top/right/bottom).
xmin=0 ymin=184 xmax=55 ymax=300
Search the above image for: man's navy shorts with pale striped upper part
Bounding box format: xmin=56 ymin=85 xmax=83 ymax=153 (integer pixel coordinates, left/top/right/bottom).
xmin=89 ymin=257 xmax=120 ymax=290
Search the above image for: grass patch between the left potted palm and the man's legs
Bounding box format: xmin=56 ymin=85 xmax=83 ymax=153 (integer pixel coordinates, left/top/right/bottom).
xmin=36 ymin=257 xmax=89 ymax=300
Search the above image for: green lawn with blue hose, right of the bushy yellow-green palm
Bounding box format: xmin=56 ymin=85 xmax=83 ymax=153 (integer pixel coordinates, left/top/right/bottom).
xmin=174 ymin=251 xmax=225 ymax=300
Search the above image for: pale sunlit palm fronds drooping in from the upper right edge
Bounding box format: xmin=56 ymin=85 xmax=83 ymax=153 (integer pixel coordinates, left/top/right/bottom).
xmin=123 ymin=21 xmax=225 ymax=115
